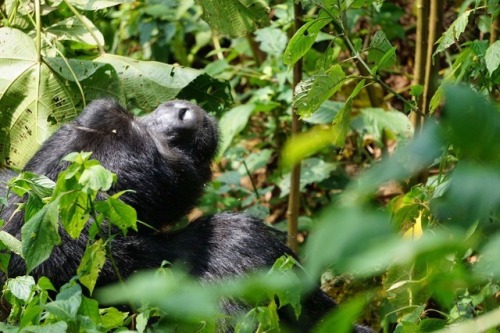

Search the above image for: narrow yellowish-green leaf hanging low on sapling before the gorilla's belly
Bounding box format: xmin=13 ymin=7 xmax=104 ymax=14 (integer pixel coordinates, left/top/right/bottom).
xmin=77 ymin=239 xmax=106 ymax=294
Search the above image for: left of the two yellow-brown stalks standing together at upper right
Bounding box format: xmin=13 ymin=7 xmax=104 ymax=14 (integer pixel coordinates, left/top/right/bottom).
xmin=410 ymin=0 xmax=431 ymax=133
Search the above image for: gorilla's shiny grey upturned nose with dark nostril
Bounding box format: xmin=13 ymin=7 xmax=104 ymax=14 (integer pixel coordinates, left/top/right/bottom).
xmin=154 ymin=100 xmax=203 ymax=130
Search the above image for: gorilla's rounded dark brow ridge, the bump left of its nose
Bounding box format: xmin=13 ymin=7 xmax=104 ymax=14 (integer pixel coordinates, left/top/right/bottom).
xmin=76 ymin=99 xmax=134 ymax=132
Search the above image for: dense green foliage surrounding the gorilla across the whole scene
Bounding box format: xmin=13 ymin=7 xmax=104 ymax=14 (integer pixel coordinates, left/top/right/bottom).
xmin=0 ymin=0 xmax=500 ymax=332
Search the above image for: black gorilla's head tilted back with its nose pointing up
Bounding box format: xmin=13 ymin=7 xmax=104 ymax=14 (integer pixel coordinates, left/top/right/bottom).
xmin=25 ymin=99 xmax=218 ymax=228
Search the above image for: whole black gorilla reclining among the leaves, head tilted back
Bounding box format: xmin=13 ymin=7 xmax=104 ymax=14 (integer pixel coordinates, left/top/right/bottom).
xmin=0 ymin=99 xmax=370 ymax=332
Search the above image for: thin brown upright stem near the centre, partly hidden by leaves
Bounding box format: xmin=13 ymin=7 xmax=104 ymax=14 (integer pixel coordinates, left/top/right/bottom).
xmin=286 ymin=2 xmax=302 ymax=251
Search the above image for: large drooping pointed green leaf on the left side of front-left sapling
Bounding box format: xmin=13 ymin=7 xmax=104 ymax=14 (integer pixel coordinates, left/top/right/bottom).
xmin=21 ymin=200 xmax=61 ymax=273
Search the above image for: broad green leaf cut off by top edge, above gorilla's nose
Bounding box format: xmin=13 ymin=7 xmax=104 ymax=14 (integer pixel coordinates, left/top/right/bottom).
xmin=196 ymin=0 xmax=269 ymax=37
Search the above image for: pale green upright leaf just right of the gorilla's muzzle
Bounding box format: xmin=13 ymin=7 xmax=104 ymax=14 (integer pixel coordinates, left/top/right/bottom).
xmin=219 ymin=104 xmax=255 ymax=156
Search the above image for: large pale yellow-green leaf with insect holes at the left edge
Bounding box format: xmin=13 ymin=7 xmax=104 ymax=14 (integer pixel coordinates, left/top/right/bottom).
xmin=0 ymin=28 xmax=76 ymax=166
